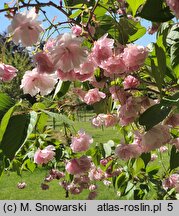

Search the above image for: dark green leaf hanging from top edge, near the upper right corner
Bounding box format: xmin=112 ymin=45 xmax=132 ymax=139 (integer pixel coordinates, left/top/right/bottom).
xmin=137 ymin=0 xmax=174 ymax=22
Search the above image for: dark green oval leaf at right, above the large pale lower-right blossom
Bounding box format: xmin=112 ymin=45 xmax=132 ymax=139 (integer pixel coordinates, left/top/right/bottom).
xmin=139 ymin=103 xmax=171 ymax=130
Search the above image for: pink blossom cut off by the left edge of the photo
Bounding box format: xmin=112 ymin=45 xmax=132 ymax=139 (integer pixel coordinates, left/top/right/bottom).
xmin=0 ymin=63 xmax=18 ymax=82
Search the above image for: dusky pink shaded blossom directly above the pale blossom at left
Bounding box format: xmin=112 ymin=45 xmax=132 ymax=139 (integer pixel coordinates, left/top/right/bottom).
xmin=34 ymin=52 xmax=54 ymax=73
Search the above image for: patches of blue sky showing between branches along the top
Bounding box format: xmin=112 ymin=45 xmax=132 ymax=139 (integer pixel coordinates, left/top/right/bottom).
xmin=0 ymin=0 xmax=155 ymax=46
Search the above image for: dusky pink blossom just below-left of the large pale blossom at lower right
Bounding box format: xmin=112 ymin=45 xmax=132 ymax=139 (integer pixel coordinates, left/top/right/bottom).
xmin=115 ymin=144 xmax=142 ymax=160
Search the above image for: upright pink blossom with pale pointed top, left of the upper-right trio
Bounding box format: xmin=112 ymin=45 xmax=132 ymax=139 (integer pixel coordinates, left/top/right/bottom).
xmin=91 ymin=34 xmax=114 ymax=66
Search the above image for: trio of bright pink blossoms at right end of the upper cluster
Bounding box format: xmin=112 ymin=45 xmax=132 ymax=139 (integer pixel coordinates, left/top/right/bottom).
xmin=90 ymin=34 xmax=148 ymax=77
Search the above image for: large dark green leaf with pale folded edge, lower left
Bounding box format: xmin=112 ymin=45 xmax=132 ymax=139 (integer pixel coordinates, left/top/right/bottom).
xmin=0 ymin=112 xmax=37 ymax=160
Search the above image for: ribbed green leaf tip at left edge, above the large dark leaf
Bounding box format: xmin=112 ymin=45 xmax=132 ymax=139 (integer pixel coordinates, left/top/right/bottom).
xmin=0 ymin=93 xmax=15 ymax=119
